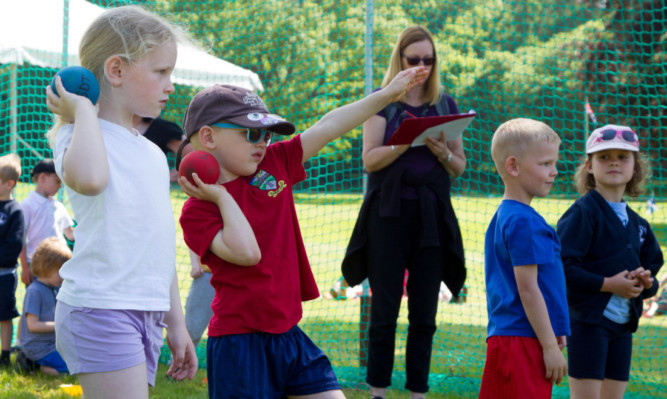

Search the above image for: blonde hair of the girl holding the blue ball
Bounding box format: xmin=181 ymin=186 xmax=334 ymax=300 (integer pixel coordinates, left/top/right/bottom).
xmin=46 ymin=6 xmax=189 ymax=147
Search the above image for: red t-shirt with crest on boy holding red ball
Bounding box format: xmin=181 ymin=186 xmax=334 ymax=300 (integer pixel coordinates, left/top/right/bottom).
xmin=180 ymin=136 xmax=319 ymax=336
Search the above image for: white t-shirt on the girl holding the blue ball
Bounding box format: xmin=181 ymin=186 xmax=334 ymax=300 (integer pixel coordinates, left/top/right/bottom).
xmin=54 ymin=119 xmax=176 ymax=311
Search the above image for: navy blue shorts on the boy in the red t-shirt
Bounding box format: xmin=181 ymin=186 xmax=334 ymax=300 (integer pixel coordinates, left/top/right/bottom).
xmin=206 ymin=326 xmax=340 ymax=399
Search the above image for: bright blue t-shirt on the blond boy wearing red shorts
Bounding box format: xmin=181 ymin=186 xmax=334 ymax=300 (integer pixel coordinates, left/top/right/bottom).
xmin=484 ymin=200 xmax=570 ymax=337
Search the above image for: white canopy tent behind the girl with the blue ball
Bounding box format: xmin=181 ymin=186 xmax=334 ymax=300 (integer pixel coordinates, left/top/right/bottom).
xmin=0 ymin=0 xmax=264 ymax=151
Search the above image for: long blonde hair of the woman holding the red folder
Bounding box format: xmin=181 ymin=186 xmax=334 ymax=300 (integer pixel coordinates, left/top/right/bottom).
xmin=382 ymin=25 xmax=442 ymax=105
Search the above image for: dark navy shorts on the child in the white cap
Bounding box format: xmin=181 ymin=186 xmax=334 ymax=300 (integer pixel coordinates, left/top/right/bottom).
xmin=567 ymin=316 xmax=632 ymax=381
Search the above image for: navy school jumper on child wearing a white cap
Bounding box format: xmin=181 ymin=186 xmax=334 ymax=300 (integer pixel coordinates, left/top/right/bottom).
xmin=557 ymin=190 xmax=663 ymax=332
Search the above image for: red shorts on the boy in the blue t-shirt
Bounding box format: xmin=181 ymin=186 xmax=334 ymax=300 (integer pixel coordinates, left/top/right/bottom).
xmin=479 ymin=336 xmax=553 ymax=399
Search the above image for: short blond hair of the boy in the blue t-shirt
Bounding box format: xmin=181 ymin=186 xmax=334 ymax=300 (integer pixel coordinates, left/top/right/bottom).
xmin=491 ymin=118 xmax=560 ymax=177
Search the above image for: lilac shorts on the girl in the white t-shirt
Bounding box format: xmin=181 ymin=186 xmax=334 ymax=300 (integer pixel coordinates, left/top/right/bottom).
xmin=55 ymin=301 xmax=166 ymax=386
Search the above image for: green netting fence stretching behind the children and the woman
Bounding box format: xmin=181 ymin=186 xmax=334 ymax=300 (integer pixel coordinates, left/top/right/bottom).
xmin=0 ymin=0 xmax=667 ymax=398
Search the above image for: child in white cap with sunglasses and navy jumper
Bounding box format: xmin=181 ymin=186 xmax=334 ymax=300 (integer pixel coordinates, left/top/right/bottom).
xmin=557 ymin=125 xmax=663 ymax=399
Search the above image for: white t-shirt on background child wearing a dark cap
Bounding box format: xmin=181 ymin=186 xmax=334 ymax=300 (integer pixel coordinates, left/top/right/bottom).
xmin=21 ymin=191 xmax=74 ymax=262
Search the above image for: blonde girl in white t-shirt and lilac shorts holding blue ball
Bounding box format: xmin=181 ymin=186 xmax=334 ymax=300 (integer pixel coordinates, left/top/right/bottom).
xmin=46 ymin=6 xmax=197 ymax=398
